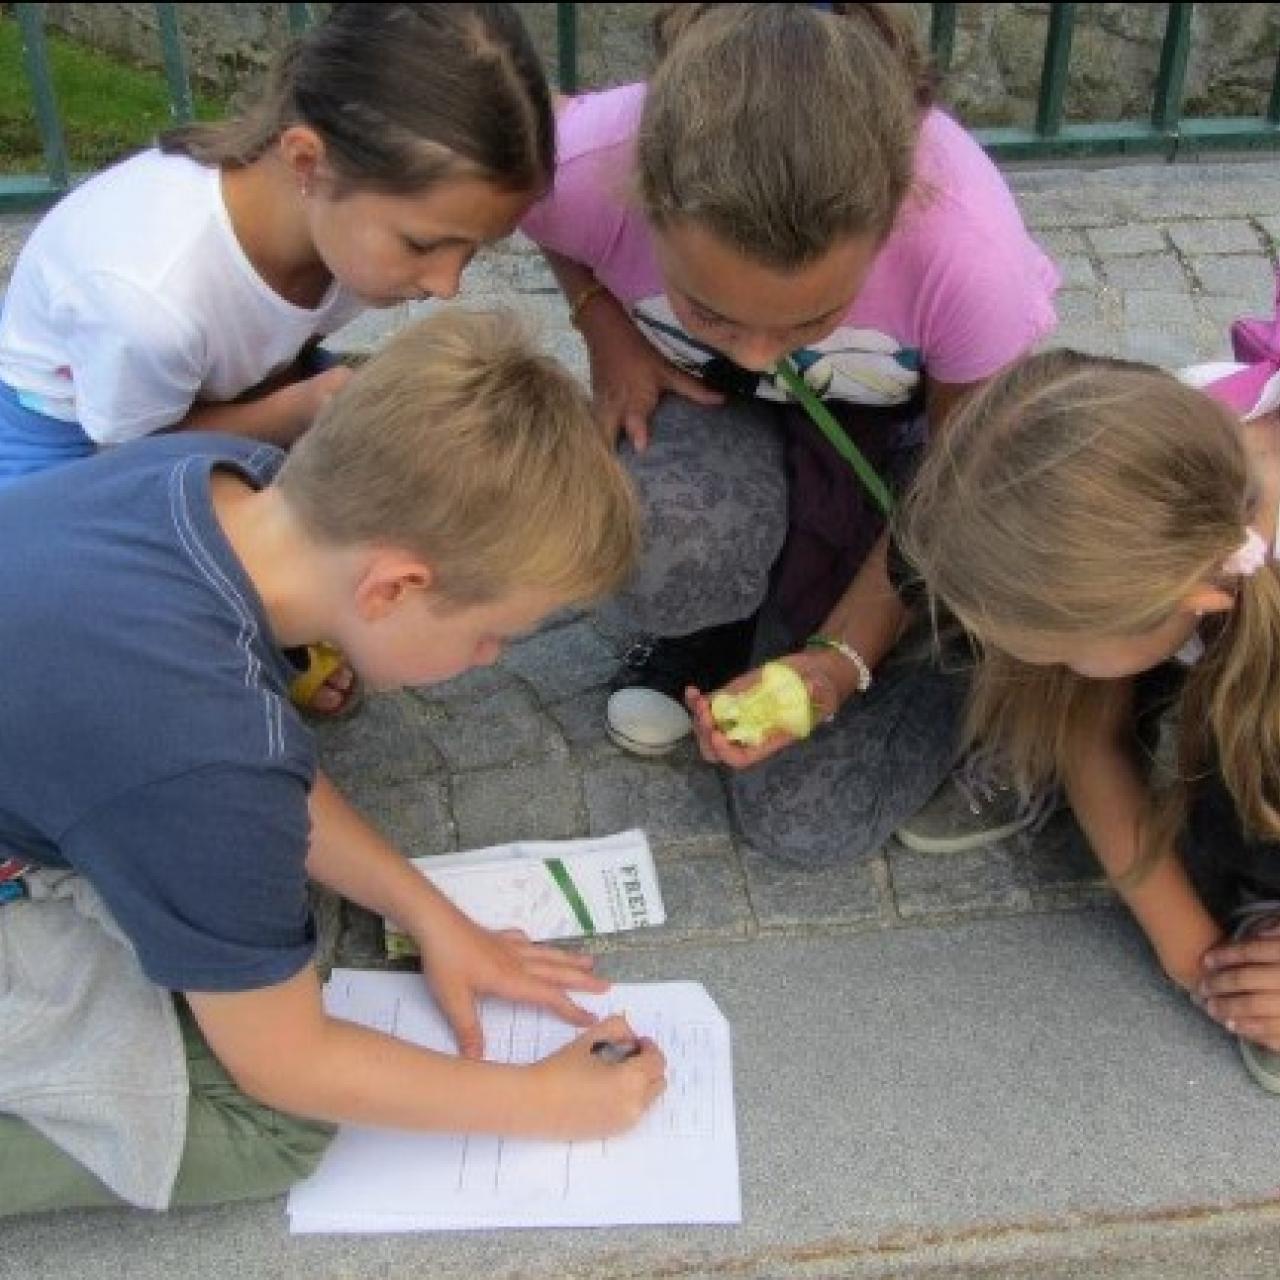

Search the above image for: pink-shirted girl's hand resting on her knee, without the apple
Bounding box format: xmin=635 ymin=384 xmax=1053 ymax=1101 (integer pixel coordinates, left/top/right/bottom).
xmin=580 ymin=293 xmax=724 ymax=452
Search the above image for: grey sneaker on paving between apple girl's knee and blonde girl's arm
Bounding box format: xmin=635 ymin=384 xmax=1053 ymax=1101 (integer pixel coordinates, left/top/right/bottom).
xmin=893 ymin=749 xmax=1060 ymax=854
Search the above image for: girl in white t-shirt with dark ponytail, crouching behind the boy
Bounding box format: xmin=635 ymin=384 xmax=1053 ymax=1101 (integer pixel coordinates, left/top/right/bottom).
xmin=0 ymin=4 xmax=554 ymax=712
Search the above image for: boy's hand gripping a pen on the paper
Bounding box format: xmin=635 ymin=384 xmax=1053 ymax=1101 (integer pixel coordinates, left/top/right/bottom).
xmin=529 ymin=1015 xmax=667 ymax=1140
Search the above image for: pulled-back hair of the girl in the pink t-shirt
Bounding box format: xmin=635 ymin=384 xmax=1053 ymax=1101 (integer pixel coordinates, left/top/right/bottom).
xmin=636 ymin=4 xmax=932 ymax=270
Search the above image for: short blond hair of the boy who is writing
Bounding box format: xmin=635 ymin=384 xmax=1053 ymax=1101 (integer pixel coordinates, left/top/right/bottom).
xmin=276 ymin=307 xmax=639 ymax=604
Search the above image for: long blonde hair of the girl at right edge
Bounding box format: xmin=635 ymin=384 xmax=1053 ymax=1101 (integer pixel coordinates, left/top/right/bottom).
xmin=897 ymin=352 xmax=1280 ymax=852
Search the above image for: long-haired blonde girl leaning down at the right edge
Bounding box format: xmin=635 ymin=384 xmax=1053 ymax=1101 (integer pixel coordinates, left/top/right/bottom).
xmin=899 ymin=294 xmax=1280 ymax=1092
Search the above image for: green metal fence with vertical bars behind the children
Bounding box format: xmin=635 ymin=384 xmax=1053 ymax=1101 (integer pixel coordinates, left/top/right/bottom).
xmin=0 ymin=4 xmax=1280 ymax=210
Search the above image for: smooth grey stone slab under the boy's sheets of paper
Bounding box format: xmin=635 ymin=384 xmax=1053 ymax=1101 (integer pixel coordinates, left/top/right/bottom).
xmin=15 ymin=911 xmax=1276 ymax=1280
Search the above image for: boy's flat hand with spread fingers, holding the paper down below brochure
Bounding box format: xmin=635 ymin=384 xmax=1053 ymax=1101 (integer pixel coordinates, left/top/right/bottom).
xmin=413 ymin=911 xmax=609 ymax=1057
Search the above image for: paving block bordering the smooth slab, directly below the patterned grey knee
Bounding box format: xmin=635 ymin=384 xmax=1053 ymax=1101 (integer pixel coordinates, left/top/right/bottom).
xmin=742 ymin=846 xmax=888 ymax=929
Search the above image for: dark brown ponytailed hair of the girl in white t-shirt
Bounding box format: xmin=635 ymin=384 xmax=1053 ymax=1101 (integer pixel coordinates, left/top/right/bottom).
xmin=160 ymin=4 xmax=556 ymax=195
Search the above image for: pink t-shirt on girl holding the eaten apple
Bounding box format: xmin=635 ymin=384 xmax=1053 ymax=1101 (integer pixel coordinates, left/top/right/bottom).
xmin=524 ymin=84 xmax=1060 ymax=404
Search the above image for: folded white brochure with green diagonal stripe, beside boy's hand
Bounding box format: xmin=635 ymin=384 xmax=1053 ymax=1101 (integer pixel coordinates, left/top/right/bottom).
xmin=385 ymin=831 xmax=667 ymax=956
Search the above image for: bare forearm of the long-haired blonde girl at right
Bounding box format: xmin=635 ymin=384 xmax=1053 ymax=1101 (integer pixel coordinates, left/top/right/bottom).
xmin=1065 ymin=685 xmax=1221 ymax=987
